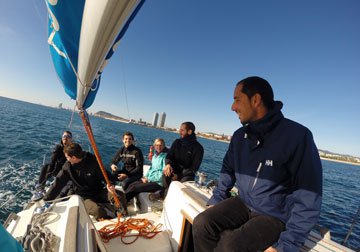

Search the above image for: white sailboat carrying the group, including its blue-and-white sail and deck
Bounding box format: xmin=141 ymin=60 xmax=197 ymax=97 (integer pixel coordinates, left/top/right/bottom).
xmin=4 ymin=0 xmax=358 ymax=252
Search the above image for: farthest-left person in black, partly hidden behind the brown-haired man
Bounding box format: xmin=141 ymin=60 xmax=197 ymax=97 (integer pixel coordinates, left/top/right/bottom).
xmin=35 ymin=131 xmax=72 ymax=191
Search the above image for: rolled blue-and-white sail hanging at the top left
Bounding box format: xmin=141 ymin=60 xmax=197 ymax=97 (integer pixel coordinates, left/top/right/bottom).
xmin=46 ymin=0 xmax=145 ymax=110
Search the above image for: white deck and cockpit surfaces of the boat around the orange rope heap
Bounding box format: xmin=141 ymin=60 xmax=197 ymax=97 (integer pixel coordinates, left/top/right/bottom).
xmin=7 ymin=173 xmax=353 ymax=252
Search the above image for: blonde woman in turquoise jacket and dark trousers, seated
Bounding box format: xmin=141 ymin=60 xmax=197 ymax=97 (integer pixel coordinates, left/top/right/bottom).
xmin=125 ymin=138 xmax=168 ymax=201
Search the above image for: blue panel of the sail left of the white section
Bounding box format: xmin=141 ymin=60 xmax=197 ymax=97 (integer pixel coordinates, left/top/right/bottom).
xmin=47 ymin=0 xmax=85 ymax=100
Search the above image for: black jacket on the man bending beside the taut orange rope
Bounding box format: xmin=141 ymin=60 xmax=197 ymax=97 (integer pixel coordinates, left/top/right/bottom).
xmin=44 ymin=152 xmax=114 ymax=200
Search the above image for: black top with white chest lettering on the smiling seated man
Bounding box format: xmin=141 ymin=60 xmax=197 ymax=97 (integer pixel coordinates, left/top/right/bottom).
xmin=111 ymin=145 xmax=144 ymax=177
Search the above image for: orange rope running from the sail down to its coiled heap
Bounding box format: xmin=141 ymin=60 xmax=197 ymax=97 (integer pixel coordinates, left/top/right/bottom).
xmin=80 ymin=110 xmax=161 ymax=244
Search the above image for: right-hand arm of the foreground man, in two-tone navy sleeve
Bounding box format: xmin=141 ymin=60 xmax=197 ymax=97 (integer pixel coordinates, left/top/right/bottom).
xmin=272 ymin=131 xmax=322 ymax=251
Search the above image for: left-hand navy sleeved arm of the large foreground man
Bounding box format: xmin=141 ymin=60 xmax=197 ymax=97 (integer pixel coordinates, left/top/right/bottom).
xmin=207 ymin=141 xmax=235 ymax=205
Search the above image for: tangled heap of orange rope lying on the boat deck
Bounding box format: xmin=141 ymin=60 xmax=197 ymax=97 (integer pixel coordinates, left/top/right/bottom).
xmin=98 ymin=214 xmax=162 ymax=245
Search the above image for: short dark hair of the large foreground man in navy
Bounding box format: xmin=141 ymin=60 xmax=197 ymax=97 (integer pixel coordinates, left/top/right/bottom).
xmin=236 ymin=76 xmax=274 ymax=109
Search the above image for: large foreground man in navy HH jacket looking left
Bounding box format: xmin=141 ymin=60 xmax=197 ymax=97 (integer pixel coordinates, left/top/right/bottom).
xmin=193 ymin=77 xmax=322 ymax=252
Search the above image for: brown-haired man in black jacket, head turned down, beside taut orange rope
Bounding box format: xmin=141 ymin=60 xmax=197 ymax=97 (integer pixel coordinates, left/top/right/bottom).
xmin=44 ymin=143 xmax=126 ymax=219
